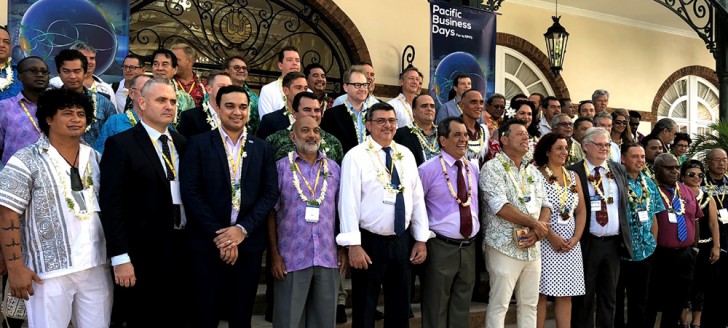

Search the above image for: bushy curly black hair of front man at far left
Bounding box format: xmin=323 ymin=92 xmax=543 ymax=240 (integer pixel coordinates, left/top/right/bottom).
xmin=35 ymin=88 xmax=96 ymax=136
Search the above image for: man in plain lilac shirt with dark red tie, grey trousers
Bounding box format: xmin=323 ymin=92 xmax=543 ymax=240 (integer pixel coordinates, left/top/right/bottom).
xmin=419 ymin=117 xmax=480 ymax=328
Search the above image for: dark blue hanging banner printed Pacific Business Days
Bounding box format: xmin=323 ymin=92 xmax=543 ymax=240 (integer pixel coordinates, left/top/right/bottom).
xmin=430 ymin=1 xmax=496 ymax=108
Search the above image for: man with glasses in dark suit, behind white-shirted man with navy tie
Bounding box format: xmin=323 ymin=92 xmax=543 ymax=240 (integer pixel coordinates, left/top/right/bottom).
xmin=321 ymin=67 xmax=376 ymax=154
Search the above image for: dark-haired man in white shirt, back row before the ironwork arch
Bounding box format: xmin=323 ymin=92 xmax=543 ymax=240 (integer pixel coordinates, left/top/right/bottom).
xmin=258 ymin=46 xmax=301 ymax=119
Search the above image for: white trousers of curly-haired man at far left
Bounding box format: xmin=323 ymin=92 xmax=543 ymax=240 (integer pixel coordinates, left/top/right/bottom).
xmin=25 ymin=265 xmax=113 ymax=328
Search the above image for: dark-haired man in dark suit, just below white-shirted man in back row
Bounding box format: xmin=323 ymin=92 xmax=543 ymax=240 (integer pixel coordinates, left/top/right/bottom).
xmin=255 ymin=71 xmax=308 ymax=140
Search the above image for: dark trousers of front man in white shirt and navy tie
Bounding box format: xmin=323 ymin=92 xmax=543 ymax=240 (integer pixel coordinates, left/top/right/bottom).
xmin=351 ymin=229 xmax=412 ymax=328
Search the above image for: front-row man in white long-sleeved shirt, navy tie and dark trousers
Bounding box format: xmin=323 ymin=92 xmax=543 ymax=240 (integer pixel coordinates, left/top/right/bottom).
xmin=336 ymin=103 xmax=430 ymax=328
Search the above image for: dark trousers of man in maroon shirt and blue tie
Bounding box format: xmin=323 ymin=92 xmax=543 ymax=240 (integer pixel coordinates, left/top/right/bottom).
xmin=647 ymin=246 xmax=695 ymax=328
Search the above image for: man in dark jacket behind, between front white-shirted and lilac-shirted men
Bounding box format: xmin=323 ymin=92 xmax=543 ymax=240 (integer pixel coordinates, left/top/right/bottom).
xmin=394 ymin=94 xmax=440 ymax=166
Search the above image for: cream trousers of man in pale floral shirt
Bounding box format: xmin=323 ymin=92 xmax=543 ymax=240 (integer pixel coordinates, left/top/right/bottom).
xmin=485 ymin=246 xmax=541 ymax=328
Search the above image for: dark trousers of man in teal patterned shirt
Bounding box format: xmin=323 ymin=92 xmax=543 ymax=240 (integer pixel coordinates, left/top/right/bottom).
xmin=614 ymin=256 xmax=653 ymax=328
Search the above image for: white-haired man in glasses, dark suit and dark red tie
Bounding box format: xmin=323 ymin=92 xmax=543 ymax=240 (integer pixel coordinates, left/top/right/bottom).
xmin=569 ymin=128 xmax=632 ymax=328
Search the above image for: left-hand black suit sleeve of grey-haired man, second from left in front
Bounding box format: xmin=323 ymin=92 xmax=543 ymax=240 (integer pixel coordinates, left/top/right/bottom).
xmin=99 ymin=138 xmax=131 ymax=258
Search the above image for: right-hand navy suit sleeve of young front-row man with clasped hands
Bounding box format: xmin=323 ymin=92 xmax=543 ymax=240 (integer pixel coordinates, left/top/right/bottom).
xmin=236 ymin=142 xmax=279 ymax=233
